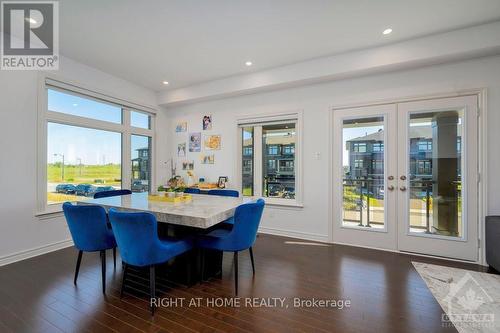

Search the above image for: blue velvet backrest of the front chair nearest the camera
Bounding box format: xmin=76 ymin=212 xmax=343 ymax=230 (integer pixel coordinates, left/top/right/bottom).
xmin=108 ymin=208 xmax=160 ymax=266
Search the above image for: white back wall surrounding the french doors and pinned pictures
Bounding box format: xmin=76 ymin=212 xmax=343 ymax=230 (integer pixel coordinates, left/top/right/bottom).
xmin=166 ymin=57 xmax=500 ymax=245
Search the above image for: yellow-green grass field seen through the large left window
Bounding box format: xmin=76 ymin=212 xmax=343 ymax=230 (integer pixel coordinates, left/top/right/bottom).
xmin=47 ymin=163 xmax=121 ymax=185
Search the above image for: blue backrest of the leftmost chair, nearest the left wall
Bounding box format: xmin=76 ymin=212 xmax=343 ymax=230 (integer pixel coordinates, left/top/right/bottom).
xmin=63 ymin=202 xmax=111 ymax=251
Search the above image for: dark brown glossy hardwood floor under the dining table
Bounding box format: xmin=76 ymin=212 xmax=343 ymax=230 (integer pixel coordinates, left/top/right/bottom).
xmin=0 ymin=235 xmax=490 ymax=333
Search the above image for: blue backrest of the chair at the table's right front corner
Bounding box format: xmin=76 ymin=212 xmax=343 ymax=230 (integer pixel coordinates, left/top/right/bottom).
xmin=228 ymin=199 xmax=265 ymax=250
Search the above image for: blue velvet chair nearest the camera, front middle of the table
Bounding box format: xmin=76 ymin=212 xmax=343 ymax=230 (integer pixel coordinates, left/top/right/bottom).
xmin=108 ymin=208 xmax=193 ymax=315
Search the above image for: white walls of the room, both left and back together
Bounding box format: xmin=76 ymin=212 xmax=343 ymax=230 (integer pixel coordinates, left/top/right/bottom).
xmin=0 ymin=52 xmax=500 ymax=265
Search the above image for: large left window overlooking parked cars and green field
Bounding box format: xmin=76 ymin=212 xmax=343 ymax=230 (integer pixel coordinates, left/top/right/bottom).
xmin=38 ymin=84 xmax=154 ymax=213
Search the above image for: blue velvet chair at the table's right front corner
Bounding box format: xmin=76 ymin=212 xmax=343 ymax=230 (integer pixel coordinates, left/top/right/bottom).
xmin=196 ymin=199 xmax=265 ymax=295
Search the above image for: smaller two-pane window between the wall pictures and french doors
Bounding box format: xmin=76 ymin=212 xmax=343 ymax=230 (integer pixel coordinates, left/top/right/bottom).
xmin=240 ymin=119 xmax=299 ymax=204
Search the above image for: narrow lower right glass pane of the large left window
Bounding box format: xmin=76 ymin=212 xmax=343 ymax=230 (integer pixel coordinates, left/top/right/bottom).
xmin=130 ymin=135 xmax=151 ymax=192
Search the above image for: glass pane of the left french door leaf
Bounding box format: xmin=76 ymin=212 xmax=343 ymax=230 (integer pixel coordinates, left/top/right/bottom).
xmin=342 ymin=117 xmax=385 ymax=229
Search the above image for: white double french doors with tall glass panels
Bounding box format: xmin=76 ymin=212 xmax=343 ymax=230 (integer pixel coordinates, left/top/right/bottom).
xmin=333 ymin=96 xmax=478 ymax=261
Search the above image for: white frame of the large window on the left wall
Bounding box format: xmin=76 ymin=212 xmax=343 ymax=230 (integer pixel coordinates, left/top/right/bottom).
xmin=35 ymin=75 xmax=156 ymax=217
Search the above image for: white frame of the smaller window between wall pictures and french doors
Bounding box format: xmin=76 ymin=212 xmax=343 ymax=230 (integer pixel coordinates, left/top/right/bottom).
xmin=236 ymin=110 xmax=303 ymax=208
